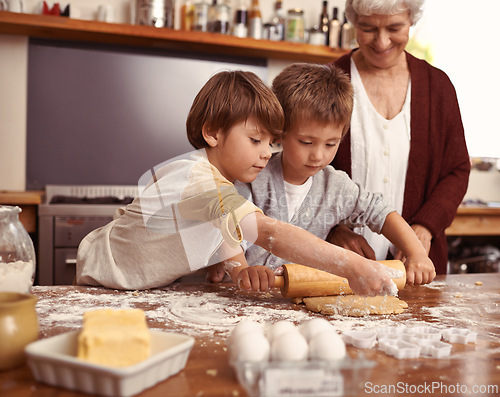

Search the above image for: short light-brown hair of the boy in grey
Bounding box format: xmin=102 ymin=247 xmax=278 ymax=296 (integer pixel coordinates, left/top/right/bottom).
xmin=273 ymin=63 xmax=353 ymax=134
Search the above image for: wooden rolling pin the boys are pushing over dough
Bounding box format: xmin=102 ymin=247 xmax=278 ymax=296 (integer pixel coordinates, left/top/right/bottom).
xmin=274 ymin=260 xmax=406 ymax=298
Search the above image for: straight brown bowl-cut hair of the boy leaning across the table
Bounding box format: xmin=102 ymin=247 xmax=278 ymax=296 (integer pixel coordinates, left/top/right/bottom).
xmin=186 ymin=70 xmax=284 ymax=149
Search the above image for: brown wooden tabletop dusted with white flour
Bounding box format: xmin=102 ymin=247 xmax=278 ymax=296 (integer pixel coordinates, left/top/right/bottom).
xmin=0 ymin=274 xmax=500 ymax=397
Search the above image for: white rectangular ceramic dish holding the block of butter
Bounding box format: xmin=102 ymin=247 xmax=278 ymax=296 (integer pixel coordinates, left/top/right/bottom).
xmin=26 ymin=330 xmax=194 ymax=397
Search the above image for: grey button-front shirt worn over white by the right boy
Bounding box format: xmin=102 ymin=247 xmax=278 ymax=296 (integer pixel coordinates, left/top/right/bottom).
xmin=235 ymin=153 xmax=394 ymax=269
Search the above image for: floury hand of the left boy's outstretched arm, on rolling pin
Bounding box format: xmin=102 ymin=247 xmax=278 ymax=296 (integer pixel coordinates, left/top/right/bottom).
xmin=347 ymin=260 xmax=398 ymax=296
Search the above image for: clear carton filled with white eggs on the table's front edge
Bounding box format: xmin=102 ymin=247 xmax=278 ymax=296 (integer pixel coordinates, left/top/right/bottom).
xmin=226 ymin=319 xmax=376 ymax=397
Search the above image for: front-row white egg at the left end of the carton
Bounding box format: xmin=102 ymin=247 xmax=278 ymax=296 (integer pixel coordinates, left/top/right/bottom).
xmin=229 ymin=332 xmax=270 ymax=362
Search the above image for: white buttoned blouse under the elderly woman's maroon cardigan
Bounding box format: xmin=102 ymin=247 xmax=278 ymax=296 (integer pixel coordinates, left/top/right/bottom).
xmin=351 ymin=59 xmax=411 ymax=260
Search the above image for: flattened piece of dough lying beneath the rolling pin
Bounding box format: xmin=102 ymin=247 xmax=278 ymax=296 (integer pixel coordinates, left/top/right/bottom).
xmin=292 ymin=295 xmax=408 ymax=317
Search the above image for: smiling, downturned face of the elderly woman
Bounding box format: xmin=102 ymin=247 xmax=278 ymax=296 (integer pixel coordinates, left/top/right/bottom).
xmin=355 ymin=12 xmax=411 ymax=69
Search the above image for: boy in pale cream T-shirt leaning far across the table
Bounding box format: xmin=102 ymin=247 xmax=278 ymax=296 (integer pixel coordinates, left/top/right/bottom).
xmin=77 ymin=71 xmax=398 ymax=295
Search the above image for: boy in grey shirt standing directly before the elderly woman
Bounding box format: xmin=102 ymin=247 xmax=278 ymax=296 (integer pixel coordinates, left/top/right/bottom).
xmin=236 ymin=64 xmax=435 ymax=284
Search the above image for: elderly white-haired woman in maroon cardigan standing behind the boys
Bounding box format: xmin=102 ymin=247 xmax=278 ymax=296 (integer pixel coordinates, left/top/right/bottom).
xmin=328 ymin=0 xmax=470 ymax=284
